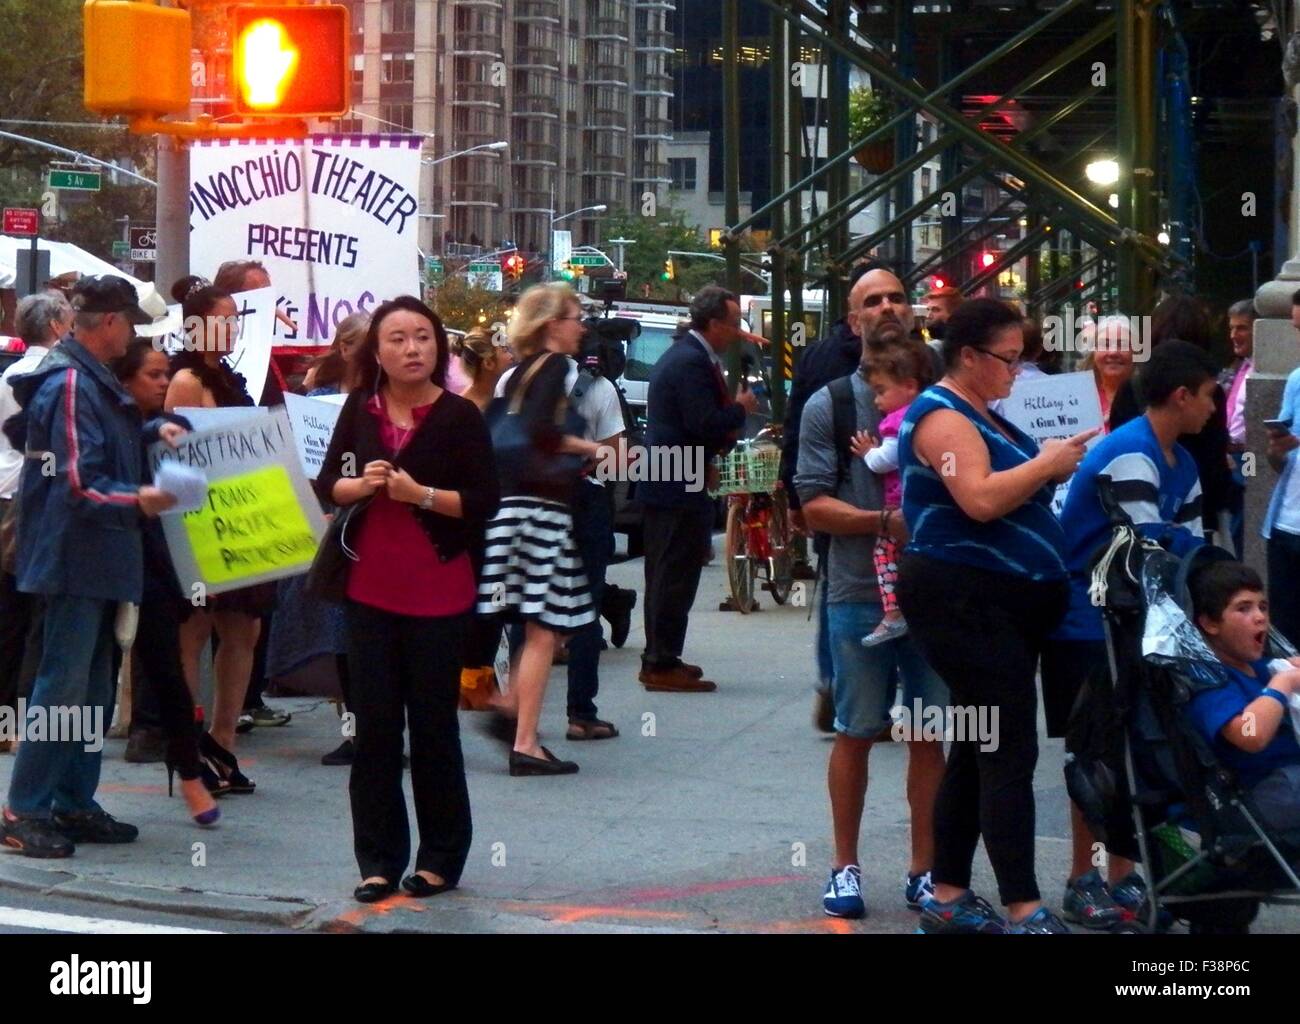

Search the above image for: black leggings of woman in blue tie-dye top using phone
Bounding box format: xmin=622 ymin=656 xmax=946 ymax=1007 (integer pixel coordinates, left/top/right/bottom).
xmin=898 ymin=554 xmax=1069 ymax=904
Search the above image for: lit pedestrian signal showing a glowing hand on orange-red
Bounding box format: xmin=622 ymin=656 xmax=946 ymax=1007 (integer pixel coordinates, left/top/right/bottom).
xmin=230 ymin=4 xmax=352 ymax=117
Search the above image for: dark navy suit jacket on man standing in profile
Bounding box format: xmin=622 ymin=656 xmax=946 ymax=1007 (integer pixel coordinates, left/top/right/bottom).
xmin=637 ymin=334 xmax=745 ymax=508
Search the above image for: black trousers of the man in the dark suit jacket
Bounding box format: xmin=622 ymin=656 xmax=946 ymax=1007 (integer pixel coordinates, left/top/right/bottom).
xmin=641 ymin=504 xmax=714 ymax=669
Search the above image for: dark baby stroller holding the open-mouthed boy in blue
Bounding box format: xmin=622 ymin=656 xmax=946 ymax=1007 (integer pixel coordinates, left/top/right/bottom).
xmin=1066 ymin=478 xmax=1300 ymax=934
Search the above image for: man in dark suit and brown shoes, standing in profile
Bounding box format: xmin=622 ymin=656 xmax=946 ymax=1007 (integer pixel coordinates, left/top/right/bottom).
xmin=638 ymin=285 xmax=757 ymax=693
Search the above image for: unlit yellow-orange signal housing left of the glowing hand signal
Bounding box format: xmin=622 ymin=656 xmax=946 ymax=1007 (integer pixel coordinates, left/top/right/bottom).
xmin=82 ymin=0 xmax=190 ymax=117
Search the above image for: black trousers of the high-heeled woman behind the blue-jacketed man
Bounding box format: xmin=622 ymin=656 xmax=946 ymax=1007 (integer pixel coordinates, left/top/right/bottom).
xmin=131 ymin=598 xmax=199 ymax=778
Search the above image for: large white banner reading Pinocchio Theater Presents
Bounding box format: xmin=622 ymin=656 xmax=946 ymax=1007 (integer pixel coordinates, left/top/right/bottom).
xmin=190 ymin=135 xmax=421 ymax=346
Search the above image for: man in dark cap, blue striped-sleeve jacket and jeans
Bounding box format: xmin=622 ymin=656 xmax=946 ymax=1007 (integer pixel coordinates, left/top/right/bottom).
xmin=0 ymin=275 xmax=183 ymax=858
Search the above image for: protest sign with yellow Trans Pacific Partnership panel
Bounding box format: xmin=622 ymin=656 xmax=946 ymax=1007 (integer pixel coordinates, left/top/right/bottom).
xmin=150 ymin=409 xmax=325 ymax=596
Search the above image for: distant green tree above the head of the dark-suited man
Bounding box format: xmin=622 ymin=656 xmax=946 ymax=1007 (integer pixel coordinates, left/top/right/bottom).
xmin=602 ymin=208 xmax=759 ymax=301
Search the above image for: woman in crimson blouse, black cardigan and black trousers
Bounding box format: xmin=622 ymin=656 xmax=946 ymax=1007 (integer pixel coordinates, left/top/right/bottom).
xmin=316 ymin=296 xmax=497 ymax=903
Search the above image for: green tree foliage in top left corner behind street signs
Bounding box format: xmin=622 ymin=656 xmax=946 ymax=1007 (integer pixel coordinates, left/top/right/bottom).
xmin=0 ymin=0 xmax=155 ymax=259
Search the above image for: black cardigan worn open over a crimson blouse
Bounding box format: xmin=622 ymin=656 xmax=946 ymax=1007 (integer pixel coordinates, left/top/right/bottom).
xmin=315 ymin=389 xmax=501 ymax=568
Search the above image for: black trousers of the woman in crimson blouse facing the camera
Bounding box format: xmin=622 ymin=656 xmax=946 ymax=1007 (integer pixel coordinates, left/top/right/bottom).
xmin=346 ymin=600 xmax=473 ymax=885
